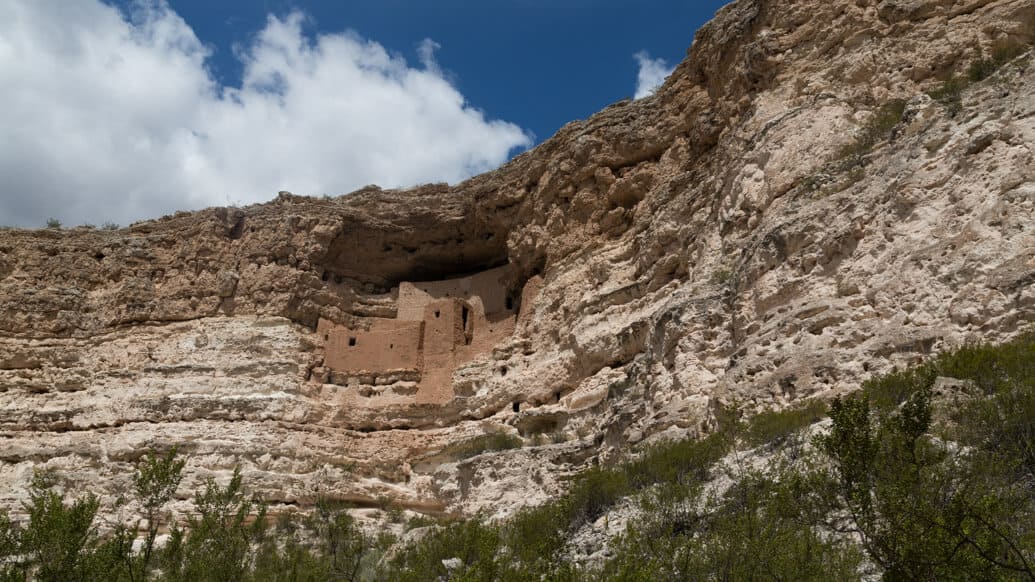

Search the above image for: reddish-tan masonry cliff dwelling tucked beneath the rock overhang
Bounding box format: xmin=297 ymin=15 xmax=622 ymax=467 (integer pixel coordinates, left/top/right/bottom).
xmin=317 ymin=266 xmax=538 ymax=403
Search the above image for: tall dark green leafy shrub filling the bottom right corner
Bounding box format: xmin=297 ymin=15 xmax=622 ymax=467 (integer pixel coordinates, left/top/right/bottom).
xmin=818 ymin=388 xmax=1035 ymax=580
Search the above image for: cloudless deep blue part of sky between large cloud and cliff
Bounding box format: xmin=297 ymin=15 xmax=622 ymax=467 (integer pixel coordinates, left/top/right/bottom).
xmin=127 ymin=0 xmax=727 ymax=142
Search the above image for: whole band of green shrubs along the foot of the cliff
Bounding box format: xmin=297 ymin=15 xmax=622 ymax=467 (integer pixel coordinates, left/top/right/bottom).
xmin=0 ymin=336 xmax=1035 ymax=581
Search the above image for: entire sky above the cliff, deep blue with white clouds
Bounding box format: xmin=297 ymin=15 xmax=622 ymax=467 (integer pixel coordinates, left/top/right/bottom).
xmin=0 ymin=0 xmax=723 ymax=227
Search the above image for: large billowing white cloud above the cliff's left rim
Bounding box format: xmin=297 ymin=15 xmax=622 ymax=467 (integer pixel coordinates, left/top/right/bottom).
xmin=0 ymin=0 xmax=531 ymax=226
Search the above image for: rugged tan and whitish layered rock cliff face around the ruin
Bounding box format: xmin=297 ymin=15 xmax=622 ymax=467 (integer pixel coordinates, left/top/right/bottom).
xmin=0 ymin=0 xmax=1035 ymax=513
